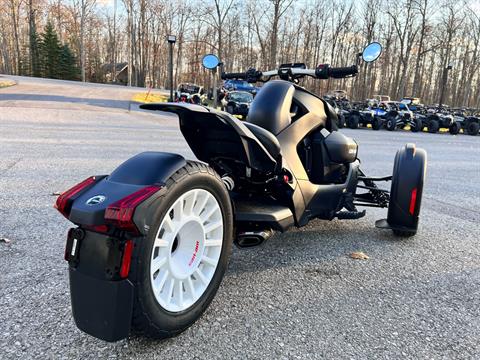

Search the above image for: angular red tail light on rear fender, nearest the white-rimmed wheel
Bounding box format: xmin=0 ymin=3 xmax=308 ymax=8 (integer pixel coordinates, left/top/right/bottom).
xmin=105 ymin=186 xmax=160 ymax=233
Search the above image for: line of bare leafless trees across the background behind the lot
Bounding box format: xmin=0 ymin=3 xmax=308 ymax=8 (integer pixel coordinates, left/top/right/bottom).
xmin=0 ymin=0 xmax=480 ymax=107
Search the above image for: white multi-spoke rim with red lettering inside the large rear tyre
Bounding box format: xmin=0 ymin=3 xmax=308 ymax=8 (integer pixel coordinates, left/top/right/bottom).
xmin=150 ymin=189 xmax=223 ymax=312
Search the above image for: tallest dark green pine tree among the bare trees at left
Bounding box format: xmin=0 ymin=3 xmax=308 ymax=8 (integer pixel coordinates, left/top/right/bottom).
xmin=39 ymin=21 xmax=62 ymax=79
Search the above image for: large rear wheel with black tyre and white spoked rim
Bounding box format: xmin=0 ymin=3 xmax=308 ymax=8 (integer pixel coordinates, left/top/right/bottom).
xmin=133 ymin=162 xmax=233 ymax=338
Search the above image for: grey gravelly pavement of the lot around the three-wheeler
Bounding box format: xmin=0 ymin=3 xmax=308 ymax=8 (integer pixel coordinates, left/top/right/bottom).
xmin=0 ymin=78 xmax=480 ymax=359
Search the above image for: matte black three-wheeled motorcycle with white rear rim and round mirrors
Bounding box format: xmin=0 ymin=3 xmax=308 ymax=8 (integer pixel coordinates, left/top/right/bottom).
xmin=56 ymin=43 xmax=426 ymax=341
